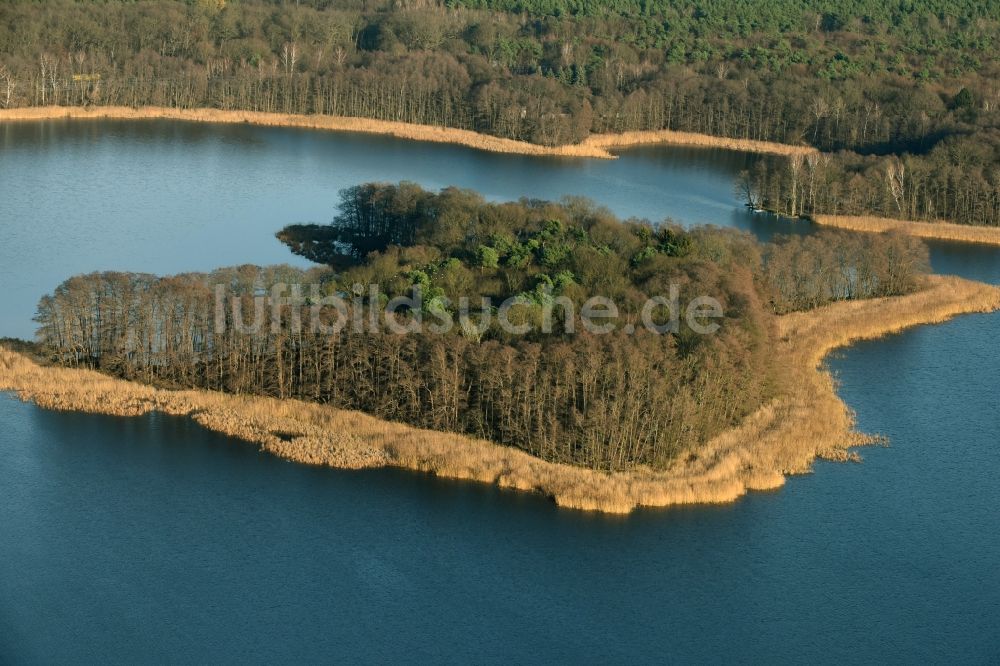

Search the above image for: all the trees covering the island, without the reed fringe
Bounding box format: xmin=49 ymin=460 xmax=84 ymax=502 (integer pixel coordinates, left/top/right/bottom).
xmin=31 ymin=183 xmax=927 ymax=470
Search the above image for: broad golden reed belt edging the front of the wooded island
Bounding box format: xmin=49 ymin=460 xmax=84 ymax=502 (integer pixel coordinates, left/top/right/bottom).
xmin=0 ymin=276 xmax=1000 ymax=514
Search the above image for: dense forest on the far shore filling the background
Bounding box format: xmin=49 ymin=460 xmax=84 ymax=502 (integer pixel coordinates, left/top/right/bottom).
xmin=0 ymin=0 xmax=1000 ymax=225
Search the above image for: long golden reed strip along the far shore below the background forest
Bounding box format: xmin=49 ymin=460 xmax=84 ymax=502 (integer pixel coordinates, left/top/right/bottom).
xmin=0 ymin=106 xmax=818 ymax=159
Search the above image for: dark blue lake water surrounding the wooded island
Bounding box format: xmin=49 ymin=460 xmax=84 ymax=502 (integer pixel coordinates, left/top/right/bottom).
xmin=0 ymin=121 xmax=1000 ymax=663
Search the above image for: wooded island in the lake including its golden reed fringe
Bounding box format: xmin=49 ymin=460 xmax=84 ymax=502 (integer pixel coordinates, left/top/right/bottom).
xmin=0 ymin=183 xmax=1000 ymax=511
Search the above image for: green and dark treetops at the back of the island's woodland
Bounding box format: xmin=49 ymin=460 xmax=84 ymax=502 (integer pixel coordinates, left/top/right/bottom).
xmin=279 ymin=183 xmax=758 ymax=326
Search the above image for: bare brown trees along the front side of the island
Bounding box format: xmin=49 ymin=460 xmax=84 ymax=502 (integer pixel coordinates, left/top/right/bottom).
xmin=31 ymin=268 xmax=763 ymax=469
